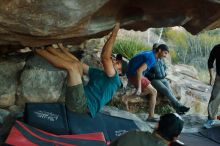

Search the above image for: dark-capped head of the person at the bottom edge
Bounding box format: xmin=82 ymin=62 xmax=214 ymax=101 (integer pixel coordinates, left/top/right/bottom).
xmin=156 ymin=113 xmax=184 ymax=141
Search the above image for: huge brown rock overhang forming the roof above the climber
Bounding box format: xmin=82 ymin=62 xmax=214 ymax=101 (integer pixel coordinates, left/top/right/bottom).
xmin=0 ymin=0 xmax=220 ymax=53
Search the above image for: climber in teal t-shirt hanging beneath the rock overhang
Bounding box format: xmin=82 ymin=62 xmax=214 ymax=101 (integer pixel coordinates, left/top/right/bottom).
xmin=34 ymin=23 xmax=121 ymax=117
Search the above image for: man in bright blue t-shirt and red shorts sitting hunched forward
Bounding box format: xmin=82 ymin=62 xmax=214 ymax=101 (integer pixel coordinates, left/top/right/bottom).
xmin=127 ymin=44 xmax=169 ymax=121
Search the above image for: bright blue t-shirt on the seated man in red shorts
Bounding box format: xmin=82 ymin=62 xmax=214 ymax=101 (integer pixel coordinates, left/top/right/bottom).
xmin=127 ymin=51 xmax=156 ymax=77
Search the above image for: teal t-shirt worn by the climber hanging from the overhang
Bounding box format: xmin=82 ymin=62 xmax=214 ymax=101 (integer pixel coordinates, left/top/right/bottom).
xmin=84 ymin=68 xmax=121 ymax=117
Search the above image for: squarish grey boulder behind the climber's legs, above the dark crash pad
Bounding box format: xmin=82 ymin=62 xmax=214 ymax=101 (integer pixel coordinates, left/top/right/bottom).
xmin=16 ymin=55 xmax=67 ymax=105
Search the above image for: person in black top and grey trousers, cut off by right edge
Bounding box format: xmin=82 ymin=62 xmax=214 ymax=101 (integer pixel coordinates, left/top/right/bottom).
xmin=204 ymin=44 xmax=220 ymax=128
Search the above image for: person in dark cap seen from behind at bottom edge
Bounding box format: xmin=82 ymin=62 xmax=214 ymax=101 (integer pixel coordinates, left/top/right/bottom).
xmin=110 ymin=113 xmax=184 ymax=146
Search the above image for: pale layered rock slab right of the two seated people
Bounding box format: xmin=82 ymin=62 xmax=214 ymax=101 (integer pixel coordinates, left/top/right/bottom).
xmin=167 ymin=65 xmax=212 ymax=115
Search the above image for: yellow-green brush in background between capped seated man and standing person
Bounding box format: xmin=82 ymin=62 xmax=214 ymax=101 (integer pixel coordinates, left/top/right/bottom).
xmin=163 ymin=28 xmax=220 ymax=82
